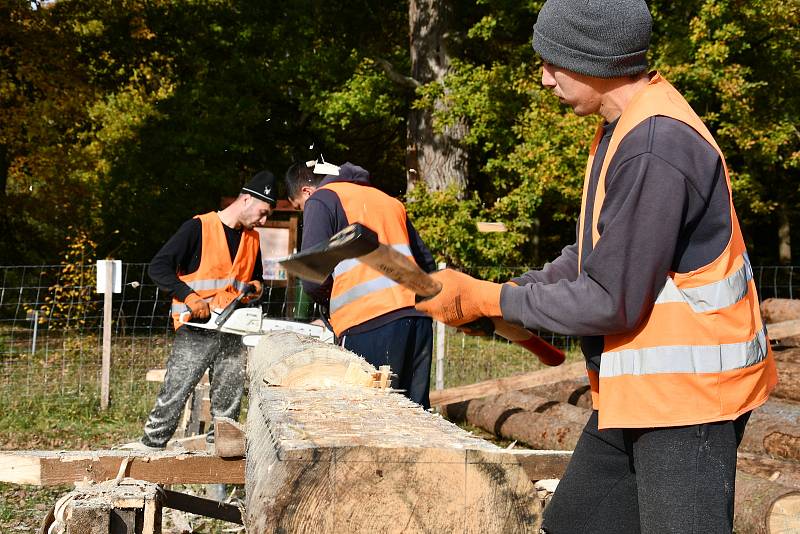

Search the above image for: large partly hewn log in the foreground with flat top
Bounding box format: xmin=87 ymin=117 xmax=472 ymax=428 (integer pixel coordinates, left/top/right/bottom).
xmin=245 ymin=333 xmax=541 ymax=533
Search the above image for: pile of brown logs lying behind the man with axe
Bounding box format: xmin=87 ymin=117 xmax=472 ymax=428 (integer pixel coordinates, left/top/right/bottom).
xmin=444 ymin=360 xmax=800 ymax=533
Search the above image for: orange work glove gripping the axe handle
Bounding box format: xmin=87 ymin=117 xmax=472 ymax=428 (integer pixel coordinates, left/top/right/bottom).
xmin=416 ymin=269 xmax=503 ymax=326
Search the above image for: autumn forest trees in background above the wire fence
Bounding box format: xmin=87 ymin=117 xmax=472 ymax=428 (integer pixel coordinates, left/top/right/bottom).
xmin=0 ymin=0 xmax=800 ymax=276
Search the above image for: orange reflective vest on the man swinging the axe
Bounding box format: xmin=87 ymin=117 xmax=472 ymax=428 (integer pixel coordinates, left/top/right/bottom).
xmin=578 ymin=73 xmax=777 ymax=428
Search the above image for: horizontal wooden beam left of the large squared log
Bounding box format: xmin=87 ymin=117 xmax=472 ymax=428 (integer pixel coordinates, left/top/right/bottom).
xmin=0 ymin=450 xmax=245 ymax=486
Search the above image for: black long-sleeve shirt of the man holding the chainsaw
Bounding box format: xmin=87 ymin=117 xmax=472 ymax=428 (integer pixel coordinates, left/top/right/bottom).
xmin=148 ymin=219 xmax=262 ymax=301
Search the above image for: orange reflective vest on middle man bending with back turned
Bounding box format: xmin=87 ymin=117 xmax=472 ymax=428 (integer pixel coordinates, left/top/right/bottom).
xmin=320 ymin=182 xmax=414 ymax=336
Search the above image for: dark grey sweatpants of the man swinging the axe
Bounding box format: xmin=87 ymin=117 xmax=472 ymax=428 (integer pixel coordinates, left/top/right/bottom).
xmin=542 ymin=411 xmax=750 ymax=534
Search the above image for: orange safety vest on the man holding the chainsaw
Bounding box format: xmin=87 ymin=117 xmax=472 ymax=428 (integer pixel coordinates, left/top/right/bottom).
xmin=171 ymin=212 xmax=259 ymax=330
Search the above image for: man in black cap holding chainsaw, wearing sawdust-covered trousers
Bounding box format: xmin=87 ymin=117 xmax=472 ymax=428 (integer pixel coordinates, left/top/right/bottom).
xmin=123 ymin=171 xmax=277 ymax=450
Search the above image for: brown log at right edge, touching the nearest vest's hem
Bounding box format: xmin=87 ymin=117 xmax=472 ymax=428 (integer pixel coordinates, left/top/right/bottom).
xmin=739 ymin=399 xmax=800 ymax=460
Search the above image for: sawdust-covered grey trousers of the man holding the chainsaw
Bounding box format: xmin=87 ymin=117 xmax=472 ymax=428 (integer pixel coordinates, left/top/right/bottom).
xmin=142 ymin=326 xmax=245 ymax=447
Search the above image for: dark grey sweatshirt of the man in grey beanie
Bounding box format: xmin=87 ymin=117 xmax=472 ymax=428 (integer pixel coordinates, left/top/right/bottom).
xmin=500 ymin=116 xmax=731 ymax=370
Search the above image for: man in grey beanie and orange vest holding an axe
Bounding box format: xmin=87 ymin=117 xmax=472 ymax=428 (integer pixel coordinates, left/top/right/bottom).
xmin=417 ymin=0 xmax=777 ymax=534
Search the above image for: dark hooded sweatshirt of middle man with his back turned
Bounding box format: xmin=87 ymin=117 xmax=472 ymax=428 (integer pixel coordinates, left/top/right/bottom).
xmin=301 ymin=163 xmax=436 ymax=335
